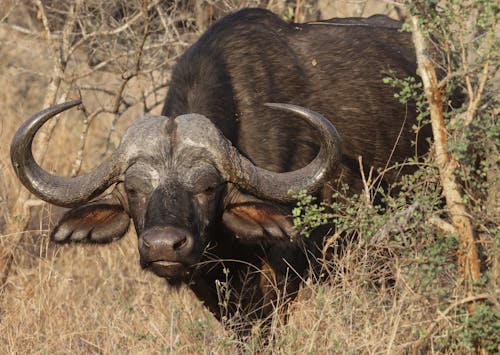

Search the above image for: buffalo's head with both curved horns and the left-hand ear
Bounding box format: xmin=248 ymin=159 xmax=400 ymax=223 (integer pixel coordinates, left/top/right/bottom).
xmin=11 ymin=101 xmax=340 ymax=280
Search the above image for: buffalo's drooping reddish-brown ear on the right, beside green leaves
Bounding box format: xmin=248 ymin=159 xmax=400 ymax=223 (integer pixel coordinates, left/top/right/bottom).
xmin=222 ymin=201 xmax=298 ymax=242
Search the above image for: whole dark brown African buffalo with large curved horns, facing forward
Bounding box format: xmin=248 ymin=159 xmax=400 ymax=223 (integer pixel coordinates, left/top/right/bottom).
xmin=11 ymin=9 xmax=429 ymax=330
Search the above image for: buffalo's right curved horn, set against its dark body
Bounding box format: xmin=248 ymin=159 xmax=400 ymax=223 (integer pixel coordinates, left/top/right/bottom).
xmin=226 ymin=103 xmax=341 ymax=202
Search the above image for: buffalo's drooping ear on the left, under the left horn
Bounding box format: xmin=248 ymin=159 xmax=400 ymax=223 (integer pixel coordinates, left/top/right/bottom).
xmin=51 ymin=187 xmax=130 ymax=243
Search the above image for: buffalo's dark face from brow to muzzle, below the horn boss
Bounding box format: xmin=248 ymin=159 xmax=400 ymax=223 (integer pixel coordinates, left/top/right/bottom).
xmin=125 ymin=156 xmax=224 ymax=279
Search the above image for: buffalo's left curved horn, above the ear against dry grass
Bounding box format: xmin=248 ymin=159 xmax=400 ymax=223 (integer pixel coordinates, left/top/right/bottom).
xmin=10 ymin=100 xmax=125 ymax=207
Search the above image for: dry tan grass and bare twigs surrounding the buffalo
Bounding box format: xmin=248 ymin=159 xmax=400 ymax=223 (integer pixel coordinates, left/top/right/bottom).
xmin=0 ymin=0 xmax=498 ymax=354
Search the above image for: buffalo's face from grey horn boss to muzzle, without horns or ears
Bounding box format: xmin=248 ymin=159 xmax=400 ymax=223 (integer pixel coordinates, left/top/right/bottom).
xmin=111 ymin=114 xmax=230 ymax=279
